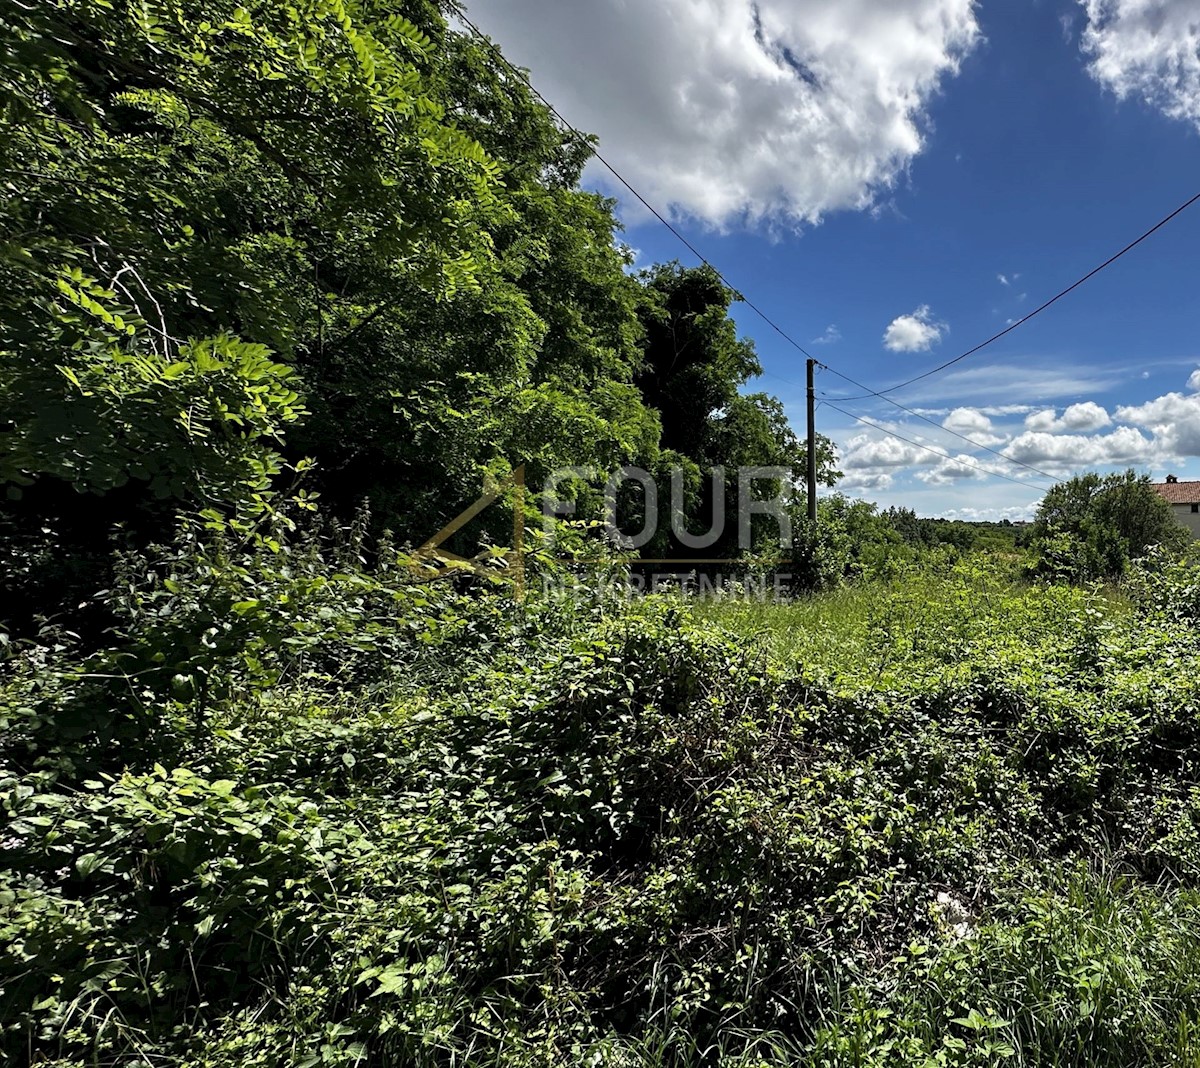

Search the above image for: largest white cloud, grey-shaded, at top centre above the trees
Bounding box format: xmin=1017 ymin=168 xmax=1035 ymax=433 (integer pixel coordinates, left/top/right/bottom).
xmin=473 ymin=0 xmax=979 ymax=227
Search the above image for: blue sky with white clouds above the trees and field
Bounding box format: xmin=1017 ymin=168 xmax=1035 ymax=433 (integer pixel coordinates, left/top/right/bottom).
xmin=469 ymin=0 xmax=1200 ymax=520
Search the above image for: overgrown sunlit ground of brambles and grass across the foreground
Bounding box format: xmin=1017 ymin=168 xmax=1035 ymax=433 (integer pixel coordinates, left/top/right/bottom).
xmin=7 ymin=554 xmax=1200 ymax=1068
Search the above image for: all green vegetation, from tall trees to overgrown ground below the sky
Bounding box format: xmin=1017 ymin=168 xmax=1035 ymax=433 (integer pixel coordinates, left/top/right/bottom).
xmin=0 ymin=0 xmax=1200 ymax=1068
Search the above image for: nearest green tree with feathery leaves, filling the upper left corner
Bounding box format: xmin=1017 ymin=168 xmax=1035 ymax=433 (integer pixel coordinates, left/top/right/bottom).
xmin=0 ymin=0 xmax=497 ymax=500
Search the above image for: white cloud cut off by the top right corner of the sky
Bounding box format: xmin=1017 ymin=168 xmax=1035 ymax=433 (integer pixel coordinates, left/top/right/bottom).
xmin=1080 ymin=0 xmax=1200 ymax=126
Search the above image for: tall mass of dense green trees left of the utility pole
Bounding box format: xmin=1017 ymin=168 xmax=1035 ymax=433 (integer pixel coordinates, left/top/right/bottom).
xmin=0 ymin=0 xmax=835 ymax=629
